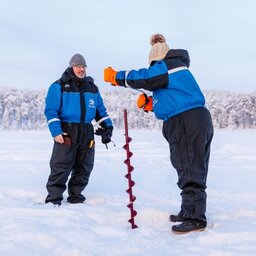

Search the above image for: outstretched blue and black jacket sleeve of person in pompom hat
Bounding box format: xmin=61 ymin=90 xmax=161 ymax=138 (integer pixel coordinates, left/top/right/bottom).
xmin=116 ymin=61 xmax=169 ymax=91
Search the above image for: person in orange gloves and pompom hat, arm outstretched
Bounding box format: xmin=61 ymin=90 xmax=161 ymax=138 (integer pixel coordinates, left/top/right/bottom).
xmin=104 ymin=34 xmax=213 ymax=233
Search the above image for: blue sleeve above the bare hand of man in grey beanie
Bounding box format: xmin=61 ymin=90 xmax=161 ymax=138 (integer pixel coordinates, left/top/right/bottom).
xmin=44 ymin=83 xmax=63 ymax=137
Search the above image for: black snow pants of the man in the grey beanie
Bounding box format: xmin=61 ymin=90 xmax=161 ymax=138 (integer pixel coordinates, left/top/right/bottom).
xmin=45 ymin=123 xmax=95 ymax=204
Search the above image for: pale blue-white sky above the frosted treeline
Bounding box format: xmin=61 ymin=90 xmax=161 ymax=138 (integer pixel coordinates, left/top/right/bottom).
xmin=0 ymin=0 xmax=256 ymax=92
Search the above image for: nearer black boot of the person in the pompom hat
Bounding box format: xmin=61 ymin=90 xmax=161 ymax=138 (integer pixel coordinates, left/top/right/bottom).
xmin=172 ymin=220 xmax=207 ymax=234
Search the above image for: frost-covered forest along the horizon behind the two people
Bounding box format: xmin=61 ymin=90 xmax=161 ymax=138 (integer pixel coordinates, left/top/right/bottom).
xmin=0 ymin=88 xmax=256 ymax=130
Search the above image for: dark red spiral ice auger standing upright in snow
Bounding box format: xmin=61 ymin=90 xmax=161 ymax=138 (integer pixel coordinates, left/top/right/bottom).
xmin=123 ymin=109 xmax=138 ymax=229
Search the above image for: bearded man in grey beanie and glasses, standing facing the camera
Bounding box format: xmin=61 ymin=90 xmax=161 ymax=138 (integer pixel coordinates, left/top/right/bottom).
xmin=45 ymin=54 xmax=113 ymax=205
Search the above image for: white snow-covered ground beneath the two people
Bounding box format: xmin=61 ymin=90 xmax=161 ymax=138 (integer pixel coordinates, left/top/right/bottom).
xmin=0 ymin=130 xmax=256 ymax=256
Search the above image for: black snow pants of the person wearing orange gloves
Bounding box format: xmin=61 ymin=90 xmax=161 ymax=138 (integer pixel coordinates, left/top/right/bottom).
xmin=163 ymin=107 xmax=213 ymax=222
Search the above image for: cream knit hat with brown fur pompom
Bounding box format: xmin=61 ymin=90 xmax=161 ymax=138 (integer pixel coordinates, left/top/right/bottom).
xmin=148 ymin=34 xmax=170 ymax=64
